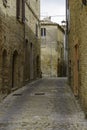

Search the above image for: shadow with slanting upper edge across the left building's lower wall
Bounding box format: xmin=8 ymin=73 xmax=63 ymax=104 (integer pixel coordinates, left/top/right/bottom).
xmin=0 ymin=9 xmax=40 ymax=98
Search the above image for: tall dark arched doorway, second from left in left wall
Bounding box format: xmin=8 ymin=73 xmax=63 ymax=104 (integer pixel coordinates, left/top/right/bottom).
xmin=12 ymin=51 xmax=18 ymax=88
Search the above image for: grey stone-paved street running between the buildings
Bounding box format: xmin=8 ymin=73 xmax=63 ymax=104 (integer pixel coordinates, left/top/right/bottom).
xmin=0 ymin=78 xmax=87 ymax=130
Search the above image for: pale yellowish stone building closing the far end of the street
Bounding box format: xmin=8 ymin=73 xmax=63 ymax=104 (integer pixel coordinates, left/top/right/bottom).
xmin=41 ymin=17 xmax=64 ymax=77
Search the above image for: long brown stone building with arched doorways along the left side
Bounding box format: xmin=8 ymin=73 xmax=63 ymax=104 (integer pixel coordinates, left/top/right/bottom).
xmin=0 ymin=0 xmax=40 ymax=97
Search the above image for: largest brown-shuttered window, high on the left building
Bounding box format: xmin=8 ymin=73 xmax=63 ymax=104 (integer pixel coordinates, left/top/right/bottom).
xmin=16 ymin=0 xmax=25 ymax=22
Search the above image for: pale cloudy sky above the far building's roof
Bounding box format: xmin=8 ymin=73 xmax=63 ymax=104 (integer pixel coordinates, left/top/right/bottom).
xmin=40 ymin=0 xmax=65 ymax=24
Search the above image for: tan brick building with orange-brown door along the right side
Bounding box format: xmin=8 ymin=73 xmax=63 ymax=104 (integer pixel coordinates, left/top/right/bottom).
xmin=67 ymin=0 xmax=87 ymax=114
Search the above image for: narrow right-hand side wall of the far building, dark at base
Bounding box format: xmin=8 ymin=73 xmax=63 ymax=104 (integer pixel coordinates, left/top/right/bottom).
xmin=57 ymin=25 xmax=67 ymax=77
